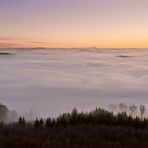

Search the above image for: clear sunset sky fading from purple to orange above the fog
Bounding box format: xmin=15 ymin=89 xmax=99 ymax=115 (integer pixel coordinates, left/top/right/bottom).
xmin=0 ymin=0 xmax=148 ymax=48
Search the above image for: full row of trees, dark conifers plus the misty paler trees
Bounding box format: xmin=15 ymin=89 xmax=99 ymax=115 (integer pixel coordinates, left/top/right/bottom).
xmin=0 ymin=103 xmax=148 ymax=128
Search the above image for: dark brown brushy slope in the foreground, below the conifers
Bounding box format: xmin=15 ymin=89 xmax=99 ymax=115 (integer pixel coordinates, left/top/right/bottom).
xmin=0 ymin=125 xmax=148 ymax=148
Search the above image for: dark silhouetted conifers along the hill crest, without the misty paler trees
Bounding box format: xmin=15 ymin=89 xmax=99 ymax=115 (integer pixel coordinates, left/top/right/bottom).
xmin=17 ymin=105 xmax=148 ymax=128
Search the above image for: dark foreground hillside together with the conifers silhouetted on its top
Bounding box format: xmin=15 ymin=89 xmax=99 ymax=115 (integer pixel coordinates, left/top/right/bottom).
xmin=0 ymin=103 xmax=148 ymax=148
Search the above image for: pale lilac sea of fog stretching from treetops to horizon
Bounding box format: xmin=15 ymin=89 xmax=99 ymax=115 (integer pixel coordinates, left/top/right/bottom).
xmin=0 ymin=49 xmax=148 ymax=117
